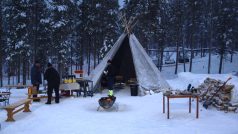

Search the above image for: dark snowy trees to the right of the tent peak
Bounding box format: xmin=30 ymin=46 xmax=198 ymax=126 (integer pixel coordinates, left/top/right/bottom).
xmin=121 ymin=0 xmax=238 ymax=74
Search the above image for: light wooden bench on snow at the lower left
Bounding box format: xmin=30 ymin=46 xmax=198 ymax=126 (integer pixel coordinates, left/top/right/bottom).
xmin=4 ymin=99 xmax=31 ymax=121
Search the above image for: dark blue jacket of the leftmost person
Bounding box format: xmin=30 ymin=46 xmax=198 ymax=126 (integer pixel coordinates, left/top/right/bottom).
xmin=31 ymin=65 xmax=42 ymax=85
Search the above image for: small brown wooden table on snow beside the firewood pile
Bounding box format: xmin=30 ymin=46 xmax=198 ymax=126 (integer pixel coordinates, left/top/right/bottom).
xmin=163 ymin=94 xmax=199 ymax=119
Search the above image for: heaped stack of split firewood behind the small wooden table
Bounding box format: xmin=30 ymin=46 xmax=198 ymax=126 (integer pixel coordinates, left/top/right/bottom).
xmin=196 ymin=78 xmax=238 ymax=112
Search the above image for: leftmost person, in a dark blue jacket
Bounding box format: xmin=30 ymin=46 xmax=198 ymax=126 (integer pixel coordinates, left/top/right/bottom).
xmin=31 ymin=60 xmax=42 ymax=101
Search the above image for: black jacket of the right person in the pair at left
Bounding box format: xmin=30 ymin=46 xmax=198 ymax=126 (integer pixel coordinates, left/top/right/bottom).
xmin=44 ymin=67 xmax=60 ymax=87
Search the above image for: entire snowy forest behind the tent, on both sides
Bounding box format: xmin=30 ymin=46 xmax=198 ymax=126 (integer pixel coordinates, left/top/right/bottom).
xmin=0 ymin=0 xmax=238 ymax=86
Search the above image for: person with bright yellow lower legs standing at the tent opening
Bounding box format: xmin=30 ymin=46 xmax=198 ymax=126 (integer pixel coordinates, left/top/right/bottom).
xmin=104 ymin=60 xmax=115 ymax=96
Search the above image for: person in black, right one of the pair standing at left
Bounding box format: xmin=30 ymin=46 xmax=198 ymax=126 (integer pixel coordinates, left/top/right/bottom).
xmin=44 ymin=63 xmax=60 ymax=104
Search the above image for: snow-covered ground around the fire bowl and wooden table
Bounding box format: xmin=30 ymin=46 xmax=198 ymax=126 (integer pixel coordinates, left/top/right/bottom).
xmin=0 ymin=73 xmax=238 ymax=134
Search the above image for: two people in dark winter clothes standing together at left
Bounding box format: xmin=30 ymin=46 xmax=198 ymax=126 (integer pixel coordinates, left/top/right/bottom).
xmin=31 ymin=61 xmax=60 ymax=104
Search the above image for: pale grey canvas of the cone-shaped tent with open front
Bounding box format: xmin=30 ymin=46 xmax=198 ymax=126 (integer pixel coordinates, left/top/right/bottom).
xmin=89 ymin=33 xmax=170 ymax=95
